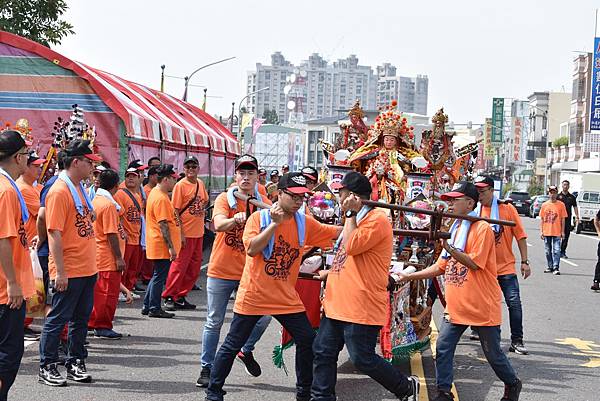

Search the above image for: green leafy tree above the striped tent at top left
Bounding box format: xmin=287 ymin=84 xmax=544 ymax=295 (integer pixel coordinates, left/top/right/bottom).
xmin=0 ymin=0 xmax=75 ymax=46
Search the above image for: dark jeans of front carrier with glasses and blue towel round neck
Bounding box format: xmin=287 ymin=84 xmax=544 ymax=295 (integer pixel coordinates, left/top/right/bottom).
xmin=206 ymin=312 xmax=315 ymax=401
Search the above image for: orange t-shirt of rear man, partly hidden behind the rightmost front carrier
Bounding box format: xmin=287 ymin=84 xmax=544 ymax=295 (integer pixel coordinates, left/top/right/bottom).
xmin=481 ymin=204 xmax=527 ymax=276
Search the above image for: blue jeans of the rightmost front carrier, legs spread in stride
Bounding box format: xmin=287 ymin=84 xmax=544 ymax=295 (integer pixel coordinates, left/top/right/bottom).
xmin=435 ymin=319 xmax=517 ymax=391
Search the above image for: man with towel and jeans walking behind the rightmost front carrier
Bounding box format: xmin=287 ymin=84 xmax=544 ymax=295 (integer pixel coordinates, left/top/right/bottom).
xmin=475 ymin=176 xmax=531 ymax=355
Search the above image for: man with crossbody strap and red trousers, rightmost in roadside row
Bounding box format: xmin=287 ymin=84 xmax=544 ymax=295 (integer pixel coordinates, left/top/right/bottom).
xmin=162 ymin=156 xmax=208 ymax=311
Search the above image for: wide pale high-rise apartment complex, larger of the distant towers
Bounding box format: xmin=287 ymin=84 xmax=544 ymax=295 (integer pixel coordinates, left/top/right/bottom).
xmin=245 ymin=52 xmax=377 ymax=123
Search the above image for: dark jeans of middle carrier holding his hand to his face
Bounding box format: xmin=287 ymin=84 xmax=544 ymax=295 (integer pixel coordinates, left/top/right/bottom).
xmin=311 ymin=317 xmax=409 ymax=401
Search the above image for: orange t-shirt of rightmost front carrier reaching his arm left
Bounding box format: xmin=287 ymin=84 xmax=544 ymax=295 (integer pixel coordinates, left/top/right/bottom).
xmin=435 ymin=221 xmax=502 ymax=326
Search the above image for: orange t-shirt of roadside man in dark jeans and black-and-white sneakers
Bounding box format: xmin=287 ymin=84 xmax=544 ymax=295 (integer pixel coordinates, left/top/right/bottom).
xmin=46 ymin=178 xmax=98 ymax=280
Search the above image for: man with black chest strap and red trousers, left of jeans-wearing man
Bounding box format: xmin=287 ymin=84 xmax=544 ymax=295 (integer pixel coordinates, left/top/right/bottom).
xmin=114 ymin=167 xmax=144 ymax=291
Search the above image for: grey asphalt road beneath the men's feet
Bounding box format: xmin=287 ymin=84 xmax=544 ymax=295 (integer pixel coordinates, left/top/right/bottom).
xmin=9 ymin=217 xmax=600 ymax=401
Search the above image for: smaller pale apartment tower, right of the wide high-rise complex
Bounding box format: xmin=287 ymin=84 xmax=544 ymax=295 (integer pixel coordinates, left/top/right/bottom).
xmin=377 ymin=63 xmax=429 ymax=115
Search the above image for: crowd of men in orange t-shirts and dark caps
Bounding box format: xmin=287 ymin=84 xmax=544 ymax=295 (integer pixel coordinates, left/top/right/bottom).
xmin=0 ymin=125 xmax=564 ymax=401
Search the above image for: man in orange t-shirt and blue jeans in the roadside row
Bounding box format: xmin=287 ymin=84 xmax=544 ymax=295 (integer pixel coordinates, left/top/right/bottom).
xmin=142 ymin=164 xmax=182 ymax=318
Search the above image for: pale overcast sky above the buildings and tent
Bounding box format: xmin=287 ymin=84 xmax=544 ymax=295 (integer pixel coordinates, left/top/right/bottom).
xmin=56 ymin=0 xmax=600 ymax=123
